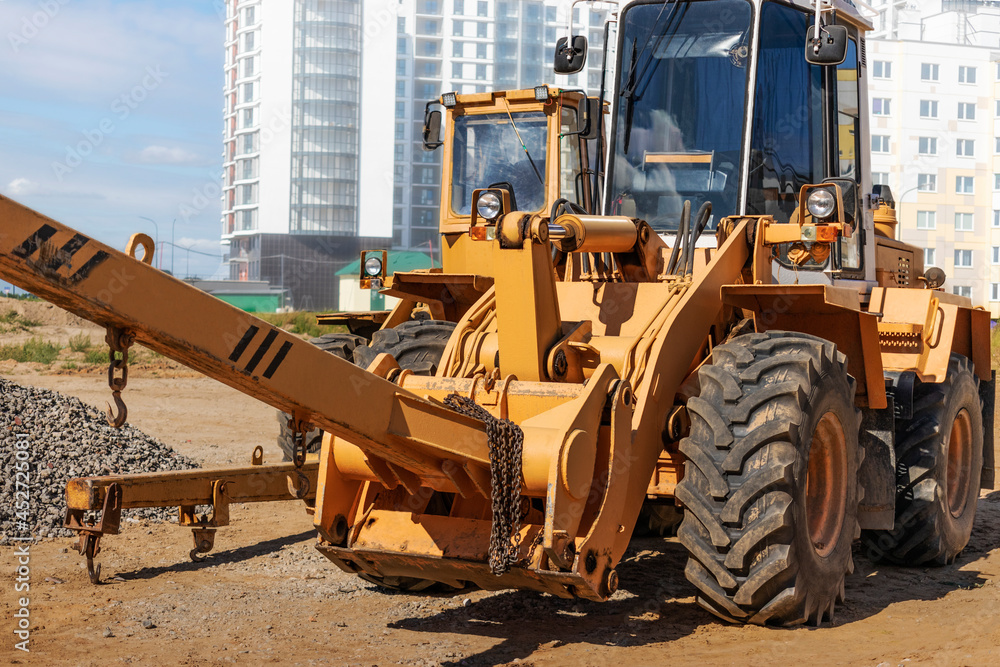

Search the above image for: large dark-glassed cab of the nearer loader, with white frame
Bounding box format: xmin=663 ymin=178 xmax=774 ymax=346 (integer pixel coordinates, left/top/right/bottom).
xmin=605 ymin=0 xmax=873 ymax=282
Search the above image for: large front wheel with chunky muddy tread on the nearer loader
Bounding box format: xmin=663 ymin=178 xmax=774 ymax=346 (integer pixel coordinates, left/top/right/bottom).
xmin=677 ymin=331 xmax=862 ymax=625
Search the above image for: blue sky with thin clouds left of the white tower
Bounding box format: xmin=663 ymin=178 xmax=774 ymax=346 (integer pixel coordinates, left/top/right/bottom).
xmin=0 ymin=0 xmax=224 ymax=284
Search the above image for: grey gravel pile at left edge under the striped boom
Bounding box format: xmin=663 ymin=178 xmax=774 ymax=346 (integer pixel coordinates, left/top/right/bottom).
xmin=0 ymin=378 xmax=198 ymax=544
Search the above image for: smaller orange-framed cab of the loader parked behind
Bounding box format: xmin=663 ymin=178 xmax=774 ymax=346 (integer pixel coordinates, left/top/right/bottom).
xmin=424 ymin=85 xmax=597 ymax=275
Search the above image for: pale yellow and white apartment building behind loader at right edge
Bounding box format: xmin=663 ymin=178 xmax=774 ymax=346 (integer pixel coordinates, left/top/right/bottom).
xmin=867 ymin=1 xmax=1000 ymax=319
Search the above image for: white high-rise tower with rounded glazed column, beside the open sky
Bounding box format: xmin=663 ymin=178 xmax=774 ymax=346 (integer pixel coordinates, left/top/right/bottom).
xmin=222 ymin=0 xmax=395 ymax=309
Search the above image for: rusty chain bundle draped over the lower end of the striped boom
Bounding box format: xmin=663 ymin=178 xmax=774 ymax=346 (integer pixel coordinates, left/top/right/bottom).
xmin=444 ymin=394 xmax=524 ymax=576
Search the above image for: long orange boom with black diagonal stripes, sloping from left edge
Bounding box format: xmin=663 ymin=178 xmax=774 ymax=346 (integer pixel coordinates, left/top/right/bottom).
xmin=0 ymin=196 xmax=489 ymax=486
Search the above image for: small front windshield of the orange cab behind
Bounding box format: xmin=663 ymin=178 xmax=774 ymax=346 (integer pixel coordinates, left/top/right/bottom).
xmin=451 ymin=111 xmax=548 ymax=215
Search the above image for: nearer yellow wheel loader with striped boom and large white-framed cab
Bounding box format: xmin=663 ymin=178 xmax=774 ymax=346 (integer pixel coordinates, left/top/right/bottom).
xmin=0 ymin=0 xmax=995 ymax=625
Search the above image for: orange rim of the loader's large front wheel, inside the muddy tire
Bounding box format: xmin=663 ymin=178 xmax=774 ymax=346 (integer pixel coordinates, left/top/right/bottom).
xmin=806 ymin=412 xmax=847 ymax=556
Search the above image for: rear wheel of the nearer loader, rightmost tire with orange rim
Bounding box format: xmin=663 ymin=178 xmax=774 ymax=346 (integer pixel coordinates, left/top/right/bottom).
xmin=862 ymin=354 xmax=984 ymax=565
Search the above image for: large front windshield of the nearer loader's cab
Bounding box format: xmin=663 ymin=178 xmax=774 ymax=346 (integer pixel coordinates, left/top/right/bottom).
xmin=610 ymin=0 xmax=751 ymax=232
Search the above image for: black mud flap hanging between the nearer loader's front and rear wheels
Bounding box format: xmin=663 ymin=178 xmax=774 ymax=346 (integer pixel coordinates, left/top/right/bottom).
xmin=858 ymin=402 xmax=896 ymax=530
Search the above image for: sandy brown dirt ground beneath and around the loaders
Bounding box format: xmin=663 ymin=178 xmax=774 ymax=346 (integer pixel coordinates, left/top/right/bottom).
xmin=0 ymin=316 xmax=1000 ymax=667
